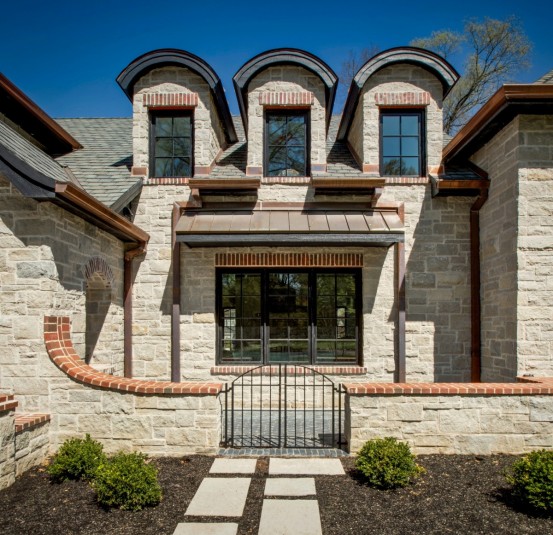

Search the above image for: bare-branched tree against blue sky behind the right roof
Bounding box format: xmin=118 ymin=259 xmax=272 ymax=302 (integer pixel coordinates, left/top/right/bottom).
xmin=410 ymin=17 xmax=531 ymax=135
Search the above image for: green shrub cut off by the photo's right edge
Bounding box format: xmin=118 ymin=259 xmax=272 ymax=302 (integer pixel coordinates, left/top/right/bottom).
xmin=507 ymin=450 xmax=553 ymax=513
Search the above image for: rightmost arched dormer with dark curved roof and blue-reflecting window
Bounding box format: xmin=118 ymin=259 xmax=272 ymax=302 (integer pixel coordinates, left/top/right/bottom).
xmin=337 ymin=47 xmax=459 ymax=176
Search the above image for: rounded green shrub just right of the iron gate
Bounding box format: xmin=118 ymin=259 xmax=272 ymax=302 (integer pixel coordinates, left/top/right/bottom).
xmin=355 ymin=437 xmax=424 ymax=489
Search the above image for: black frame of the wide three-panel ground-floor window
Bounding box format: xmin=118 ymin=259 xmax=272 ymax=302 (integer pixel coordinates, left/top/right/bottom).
xmin=215 ymin=266 xmax=363 ymax=367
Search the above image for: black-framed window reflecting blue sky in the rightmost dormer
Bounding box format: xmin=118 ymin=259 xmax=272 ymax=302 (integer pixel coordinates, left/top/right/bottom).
xmin=380 ymin=110 xmax=424 ymax=176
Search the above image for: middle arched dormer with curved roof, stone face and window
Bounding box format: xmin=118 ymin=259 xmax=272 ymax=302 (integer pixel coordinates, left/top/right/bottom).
xmin=233 ymin=48 xmax=338 ymax=176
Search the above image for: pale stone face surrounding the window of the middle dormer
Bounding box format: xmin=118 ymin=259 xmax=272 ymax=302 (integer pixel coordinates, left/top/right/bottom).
xmin=247 ymin=66 xmax=326 ymax=174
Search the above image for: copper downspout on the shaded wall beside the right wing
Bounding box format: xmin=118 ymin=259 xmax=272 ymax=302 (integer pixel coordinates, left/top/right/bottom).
xmin=470 ymin=185 xmax=488 ymax=383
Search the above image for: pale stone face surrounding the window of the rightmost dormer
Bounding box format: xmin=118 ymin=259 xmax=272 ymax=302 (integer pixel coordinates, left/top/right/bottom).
xmin=348 ymin=64 xmax=443 ymax=174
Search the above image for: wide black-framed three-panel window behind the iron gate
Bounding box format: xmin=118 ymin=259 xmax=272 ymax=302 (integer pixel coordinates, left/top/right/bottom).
xmin=217 ymin=270 xmax=361 ymax=364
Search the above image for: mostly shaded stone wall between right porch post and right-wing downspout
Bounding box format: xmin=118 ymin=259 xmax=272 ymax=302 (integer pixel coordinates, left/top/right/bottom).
xmin=405 ymin=191 xmax=474 ymax=382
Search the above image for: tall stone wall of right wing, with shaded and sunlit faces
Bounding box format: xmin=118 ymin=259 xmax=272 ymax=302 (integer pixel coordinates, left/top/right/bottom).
xmin=473 ymin=115 xmax=553 ymax=381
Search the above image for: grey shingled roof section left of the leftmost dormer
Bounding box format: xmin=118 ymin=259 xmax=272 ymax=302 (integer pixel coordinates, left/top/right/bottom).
xmin=56 ymin=117 xmax=141 ymax=210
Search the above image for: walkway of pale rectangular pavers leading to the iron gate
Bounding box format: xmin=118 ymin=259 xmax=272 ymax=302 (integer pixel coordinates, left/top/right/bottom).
xmin=173 ymin=458 xmax=345 ymax=535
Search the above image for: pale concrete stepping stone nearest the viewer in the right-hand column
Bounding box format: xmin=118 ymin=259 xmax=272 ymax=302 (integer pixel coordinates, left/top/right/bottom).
xmin=258 ymin=500 xmax=323 ymax=535
